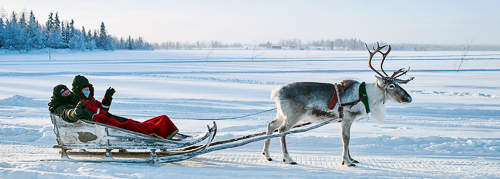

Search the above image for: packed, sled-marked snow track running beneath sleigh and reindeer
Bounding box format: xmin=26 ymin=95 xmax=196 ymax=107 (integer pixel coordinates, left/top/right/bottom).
xmin=0 ymin=144 xmax=500 ymax=178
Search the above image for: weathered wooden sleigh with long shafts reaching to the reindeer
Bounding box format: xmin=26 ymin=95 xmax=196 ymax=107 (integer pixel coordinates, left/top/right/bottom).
xmin=42 ymin=113 xmax=338 ymax=163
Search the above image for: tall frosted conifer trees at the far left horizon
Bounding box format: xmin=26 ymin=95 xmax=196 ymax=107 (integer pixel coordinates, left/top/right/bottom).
xmin=0 ymin=11 xmax=153 ymax=52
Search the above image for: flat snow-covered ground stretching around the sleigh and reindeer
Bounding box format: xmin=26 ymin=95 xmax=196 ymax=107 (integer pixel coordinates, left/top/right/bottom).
xmin=0 ymin=49 xmax=500 ymax=178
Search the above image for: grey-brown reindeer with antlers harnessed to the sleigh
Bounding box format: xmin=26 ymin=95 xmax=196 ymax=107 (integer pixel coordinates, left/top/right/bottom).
xmin=262 ymin=43 xmax=413 ymax=167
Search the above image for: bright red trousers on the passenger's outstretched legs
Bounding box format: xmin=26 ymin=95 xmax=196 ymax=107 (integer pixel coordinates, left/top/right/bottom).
xmin=92 ymin=114 xmax=179 ymax=139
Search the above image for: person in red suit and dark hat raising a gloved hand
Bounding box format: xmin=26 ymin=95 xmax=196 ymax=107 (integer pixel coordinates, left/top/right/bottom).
xmin=72 ymin=75 xmax=179 ymax=139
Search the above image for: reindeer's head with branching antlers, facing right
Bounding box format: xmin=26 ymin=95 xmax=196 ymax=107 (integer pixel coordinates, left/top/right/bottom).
xmin=365 ymin=42 xmax=413 ymax=103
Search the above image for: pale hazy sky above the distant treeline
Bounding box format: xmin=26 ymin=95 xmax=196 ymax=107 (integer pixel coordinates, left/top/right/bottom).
xmin=0 ymin=0 xmax=500 ymax=45
